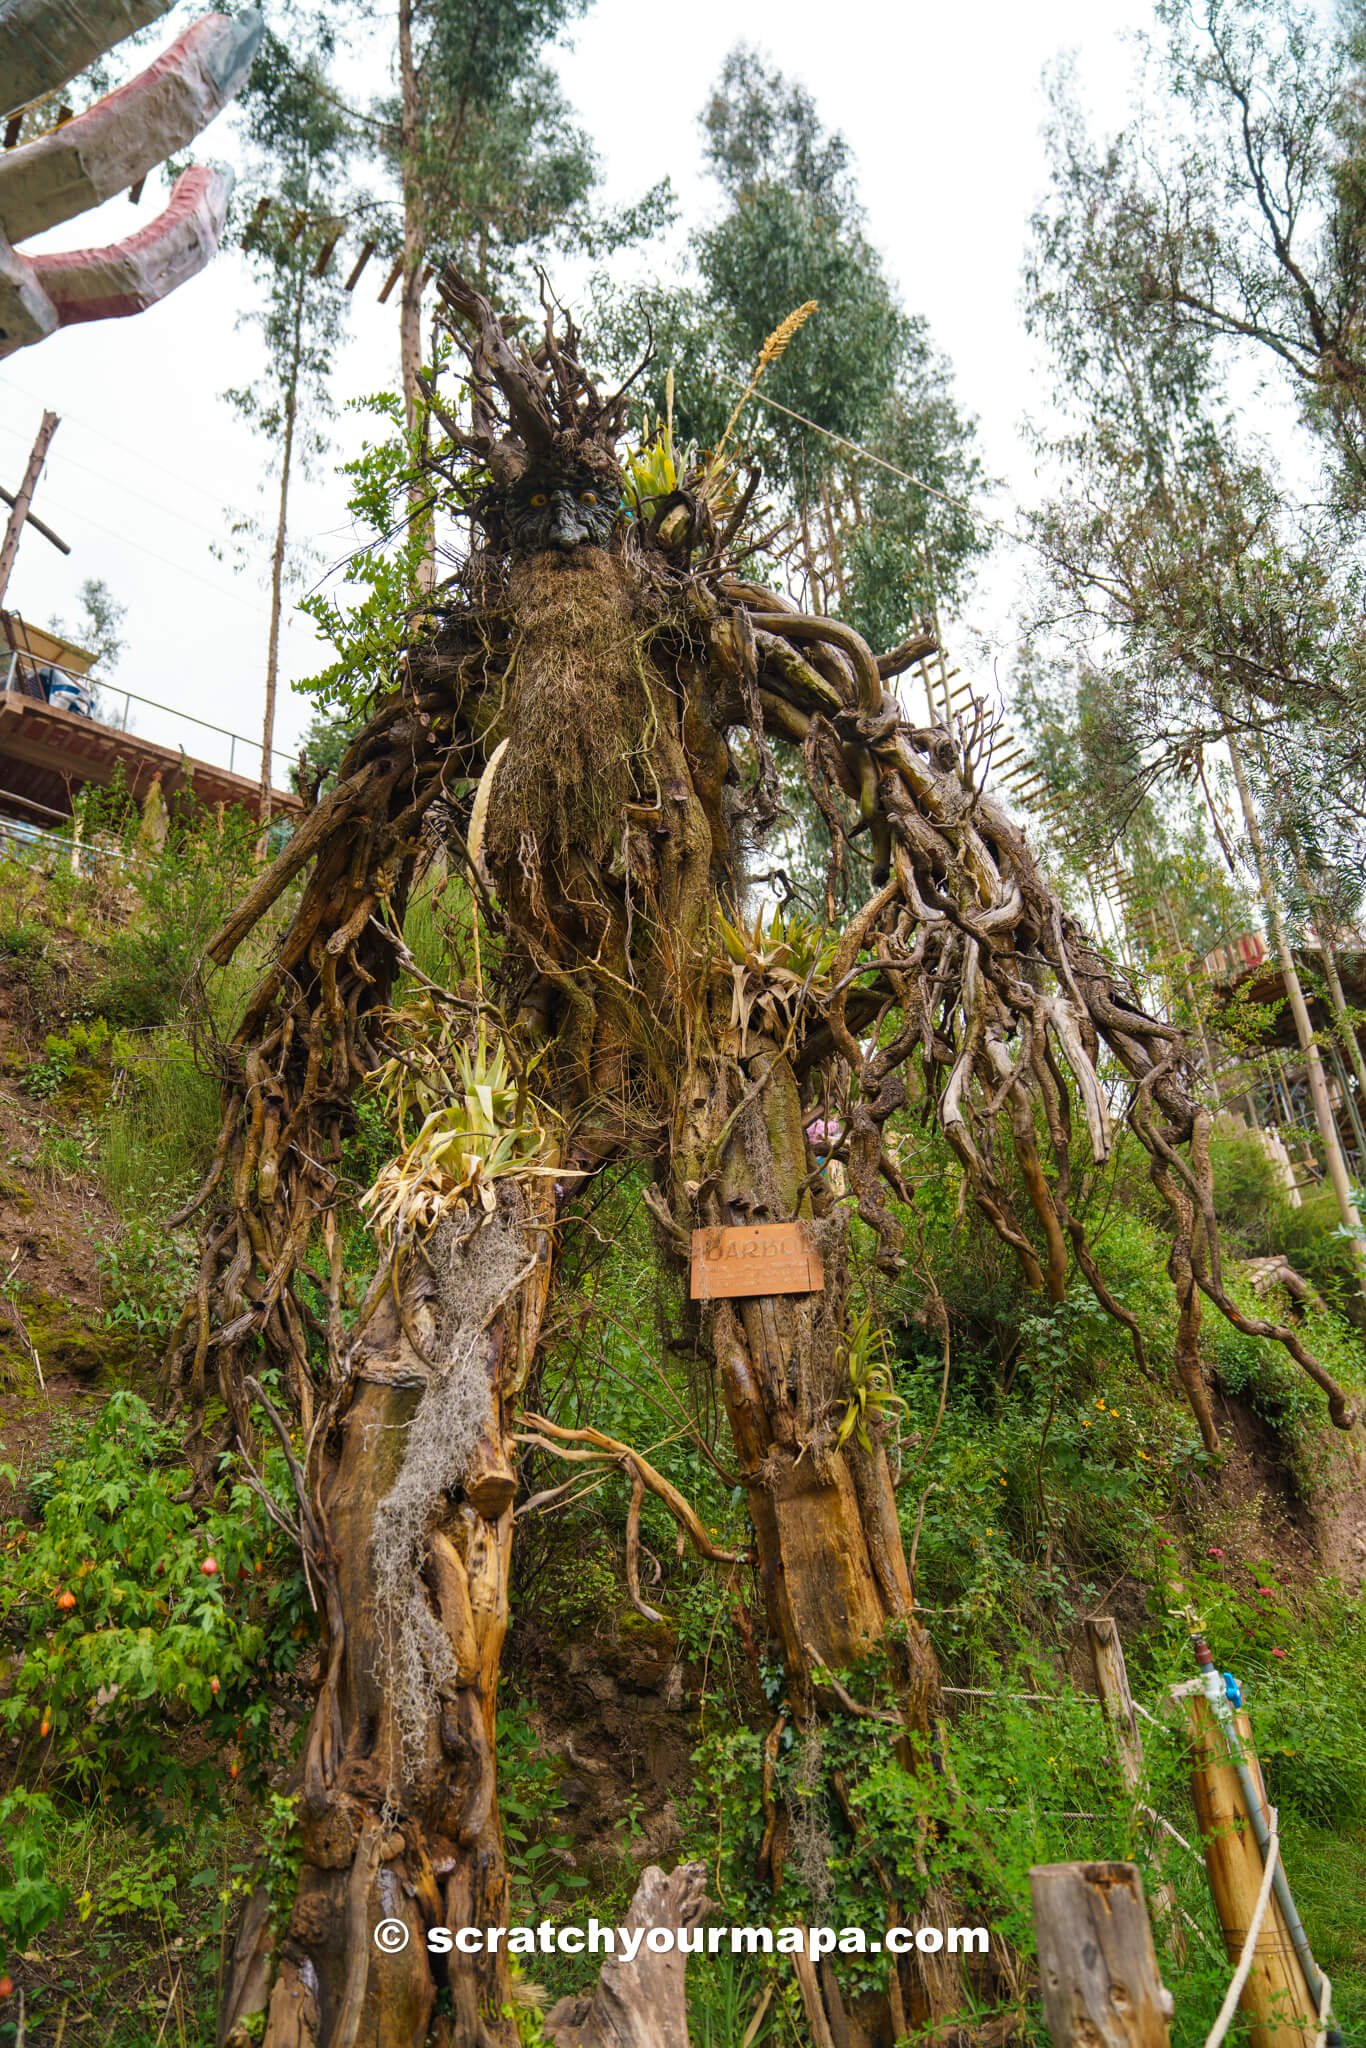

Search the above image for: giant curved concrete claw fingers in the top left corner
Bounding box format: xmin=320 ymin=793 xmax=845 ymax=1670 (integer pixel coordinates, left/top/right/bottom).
xmin=0 ymin=0 xmax=262 ymax=356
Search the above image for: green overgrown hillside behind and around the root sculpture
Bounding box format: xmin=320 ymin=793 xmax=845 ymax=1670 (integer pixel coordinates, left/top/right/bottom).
xmin=0 ymin=815 xmax=1366 ymax=2048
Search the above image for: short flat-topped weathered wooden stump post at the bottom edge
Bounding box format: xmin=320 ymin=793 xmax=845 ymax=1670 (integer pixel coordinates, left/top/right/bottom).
xmin=1030 ymin=1864 xmax=1173 ymax=2048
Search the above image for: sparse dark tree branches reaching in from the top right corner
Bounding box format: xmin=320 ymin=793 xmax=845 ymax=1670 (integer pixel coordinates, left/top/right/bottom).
xmin=1056 ymin=0 xmax=1366 ymax=502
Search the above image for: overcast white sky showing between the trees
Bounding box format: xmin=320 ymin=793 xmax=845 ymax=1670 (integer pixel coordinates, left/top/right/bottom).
xmin=0 ymin=0 xmax=1151 ymax=790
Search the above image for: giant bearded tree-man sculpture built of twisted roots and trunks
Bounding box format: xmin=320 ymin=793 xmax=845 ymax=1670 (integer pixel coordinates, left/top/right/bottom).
xmin=192 ymin=272 xmax=1352 ymax=2048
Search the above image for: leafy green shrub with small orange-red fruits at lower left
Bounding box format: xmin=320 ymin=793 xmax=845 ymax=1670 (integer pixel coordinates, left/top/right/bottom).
xmin=0 ymin=1393 xmax=307 ymax=1796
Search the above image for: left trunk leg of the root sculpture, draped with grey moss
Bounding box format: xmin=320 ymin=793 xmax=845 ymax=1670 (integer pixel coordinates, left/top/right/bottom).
xmin=225 ymin=1182 xmax=553 ymax=2048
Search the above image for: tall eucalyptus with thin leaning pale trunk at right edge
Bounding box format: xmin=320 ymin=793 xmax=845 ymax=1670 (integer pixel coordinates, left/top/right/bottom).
xmin=1028 ymin=75 xmax=1366 ymax=1233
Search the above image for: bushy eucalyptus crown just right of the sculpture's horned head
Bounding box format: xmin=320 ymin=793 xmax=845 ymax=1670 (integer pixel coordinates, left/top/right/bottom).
xmin=610 ymin=47 xmax=981 ymax=645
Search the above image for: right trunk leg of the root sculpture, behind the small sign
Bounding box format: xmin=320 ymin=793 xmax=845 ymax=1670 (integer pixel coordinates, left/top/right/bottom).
xmin=674 ymin=1042 xmax=963 ymax=2042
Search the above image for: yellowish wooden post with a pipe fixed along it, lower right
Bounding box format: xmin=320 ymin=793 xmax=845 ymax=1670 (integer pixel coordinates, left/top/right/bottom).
xmin=1186 ymin=1694 xmax=1319 ymax=2048
